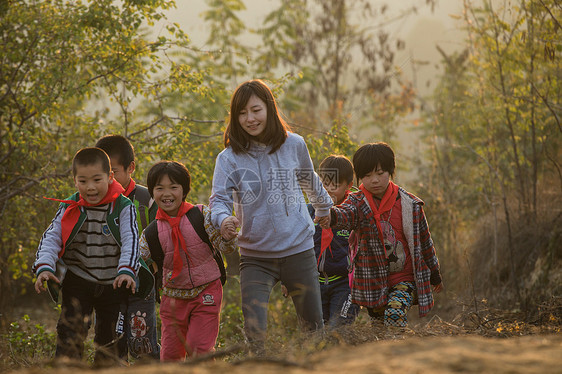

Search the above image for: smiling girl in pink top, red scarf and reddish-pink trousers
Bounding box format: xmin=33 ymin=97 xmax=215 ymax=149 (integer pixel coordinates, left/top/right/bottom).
xmin=140 ymin=161 xmax=236 ymax=361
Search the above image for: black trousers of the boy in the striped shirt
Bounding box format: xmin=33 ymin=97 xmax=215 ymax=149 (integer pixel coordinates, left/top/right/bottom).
xmin=55 ymin=271 xmax=124 ymax=363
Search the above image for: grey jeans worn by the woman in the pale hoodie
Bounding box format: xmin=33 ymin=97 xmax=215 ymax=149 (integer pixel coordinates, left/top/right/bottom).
xmin=240 ymin=249 xmax=324 ymax=354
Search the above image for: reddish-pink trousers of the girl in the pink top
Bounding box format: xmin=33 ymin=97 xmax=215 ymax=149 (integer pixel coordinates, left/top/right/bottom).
xmin=160 ymin=279 xmax=222 ymax=361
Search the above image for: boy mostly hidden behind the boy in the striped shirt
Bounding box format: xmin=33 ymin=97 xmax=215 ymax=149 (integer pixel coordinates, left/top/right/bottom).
xmin=96 ymin=135 xmax=160 ymax=359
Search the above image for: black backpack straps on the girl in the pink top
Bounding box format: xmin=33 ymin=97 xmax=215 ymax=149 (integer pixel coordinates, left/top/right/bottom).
xmin=144 ymin=205 xmax=226 ymax=298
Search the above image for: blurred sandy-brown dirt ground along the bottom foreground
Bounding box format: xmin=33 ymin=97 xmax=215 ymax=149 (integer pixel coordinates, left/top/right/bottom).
xmin=14 ymin=334 xmax=562 ymax=374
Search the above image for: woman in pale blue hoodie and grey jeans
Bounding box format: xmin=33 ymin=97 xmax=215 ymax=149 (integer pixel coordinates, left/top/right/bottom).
xmin=209 ymin=80 xmax=332 ymax=355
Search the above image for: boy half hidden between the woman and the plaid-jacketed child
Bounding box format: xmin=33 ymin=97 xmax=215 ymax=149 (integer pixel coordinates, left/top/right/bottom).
xmin=308 ymin=155 xmax=359 ymax=328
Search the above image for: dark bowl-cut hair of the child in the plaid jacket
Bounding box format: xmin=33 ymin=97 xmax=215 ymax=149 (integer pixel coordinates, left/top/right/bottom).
xmin=353 ymin=142 xmax=396 ymax=179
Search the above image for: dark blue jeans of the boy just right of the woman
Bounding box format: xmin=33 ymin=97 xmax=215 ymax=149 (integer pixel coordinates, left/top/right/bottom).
xmin=320 ymin=277 xmax=360 ymax=328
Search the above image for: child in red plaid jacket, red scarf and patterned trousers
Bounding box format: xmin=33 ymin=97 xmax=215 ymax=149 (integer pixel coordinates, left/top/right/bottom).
xmin=322 ymin=142 xmax=443 ymax=327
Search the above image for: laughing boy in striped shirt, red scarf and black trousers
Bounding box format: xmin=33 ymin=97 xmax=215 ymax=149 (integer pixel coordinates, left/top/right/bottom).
xmin=33 ymin=148 xmax=139 ymax=364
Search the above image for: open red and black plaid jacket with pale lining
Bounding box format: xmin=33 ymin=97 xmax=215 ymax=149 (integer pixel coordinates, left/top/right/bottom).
xmin=331 ymin=188 xmax=441 ymax=317
